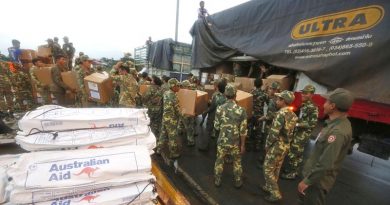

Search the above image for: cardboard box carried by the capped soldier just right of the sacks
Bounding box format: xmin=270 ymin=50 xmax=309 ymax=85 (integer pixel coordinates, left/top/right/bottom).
xmin=177 ymin=89 xmax=209 ymax=116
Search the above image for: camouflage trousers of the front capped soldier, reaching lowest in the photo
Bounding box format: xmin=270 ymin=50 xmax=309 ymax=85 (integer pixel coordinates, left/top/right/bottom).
xmin=263 ymin=141 xmax=290 ymax=199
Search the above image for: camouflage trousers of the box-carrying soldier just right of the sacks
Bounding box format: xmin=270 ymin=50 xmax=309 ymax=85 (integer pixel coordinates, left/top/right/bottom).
xmin=157 ymin=120 xmax=180 ymax=158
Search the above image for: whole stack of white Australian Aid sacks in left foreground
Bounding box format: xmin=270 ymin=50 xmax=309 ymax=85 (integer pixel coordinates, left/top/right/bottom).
xmin=0 ymin=106 xmax=156 ymax=205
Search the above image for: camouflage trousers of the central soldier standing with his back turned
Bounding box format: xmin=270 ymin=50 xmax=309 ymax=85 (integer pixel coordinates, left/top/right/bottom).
xmin=214 ymin=145 xmax=242 ymax=181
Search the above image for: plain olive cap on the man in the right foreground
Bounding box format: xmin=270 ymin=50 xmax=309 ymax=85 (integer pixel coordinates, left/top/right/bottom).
xmin=323 ymin=88 xmax=355 ymax=110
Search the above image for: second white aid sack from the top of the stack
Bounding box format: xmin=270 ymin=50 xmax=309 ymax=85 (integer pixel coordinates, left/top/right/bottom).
xmin=15 ymin=125 xmax=156 ymax=153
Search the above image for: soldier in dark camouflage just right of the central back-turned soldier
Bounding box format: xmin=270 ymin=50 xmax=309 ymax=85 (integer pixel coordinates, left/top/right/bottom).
xmin=250 ymin=78 xmax=268 ymax=150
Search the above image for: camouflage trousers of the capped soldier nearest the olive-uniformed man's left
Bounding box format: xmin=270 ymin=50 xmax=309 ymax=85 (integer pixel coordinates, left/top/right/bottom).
xmin=287 ymin=129 xmax=312 ymax=175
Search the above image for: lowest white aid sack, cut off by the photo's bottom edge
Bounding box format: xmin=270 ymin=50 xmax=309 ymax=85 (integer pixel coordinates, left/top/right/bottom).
xmin=35 ymin=181 xmax=156 ymax=205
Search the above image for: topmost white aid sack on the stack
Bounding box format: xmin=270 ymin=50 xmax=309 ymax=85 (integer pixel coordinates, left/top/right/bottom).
xmin=18 ymin=106 xmax=150 ymax=134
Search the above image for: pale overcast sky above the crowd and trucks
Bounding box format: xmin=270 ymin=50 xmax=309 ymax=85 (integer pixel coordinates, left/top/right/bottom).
xmin=0 ymin=0 xmax=248 ymax=59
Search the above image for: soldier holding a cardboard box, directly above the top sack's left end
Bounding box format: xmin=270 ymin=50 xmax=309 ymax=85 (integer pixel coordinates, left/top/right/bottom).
xmin=30 ymin=58 xmax=50 ymax=105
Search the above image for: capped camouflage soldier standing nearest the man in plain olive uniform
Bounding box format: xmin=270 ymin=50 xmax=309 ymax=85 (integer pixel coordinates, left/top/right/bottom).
xmin=280 ymin=85 xmax=318 ymax=179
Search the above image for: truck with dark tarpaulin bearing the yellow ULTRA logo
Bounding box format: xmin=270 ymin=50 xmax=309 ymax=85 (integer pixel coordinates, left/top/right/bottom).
xmin=191 ymin=0 xmax=390 ymax=160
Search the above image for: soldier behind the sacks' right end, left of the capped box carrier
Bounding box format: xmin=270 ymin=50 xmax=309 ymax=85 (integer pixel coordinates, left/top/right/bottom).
xmin=142 ymin=75 xmax=163 ymax=137
